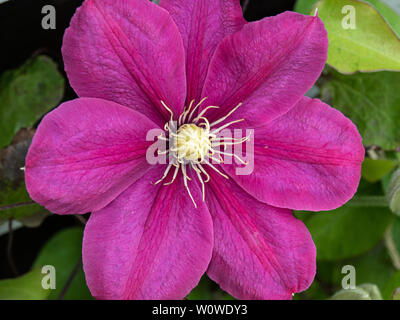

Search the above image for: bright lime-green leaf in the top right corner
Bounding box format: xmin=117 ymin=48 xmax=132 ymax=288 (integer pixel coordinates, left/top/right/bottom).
xmin=316 ymin=0 xmax=400 ymax=73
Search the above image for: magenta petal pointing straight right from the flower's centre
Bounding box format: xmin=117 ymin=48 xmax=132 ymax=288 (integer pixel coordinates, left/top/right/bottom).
xmin=224 ymin=97 xmax=364 ymax=211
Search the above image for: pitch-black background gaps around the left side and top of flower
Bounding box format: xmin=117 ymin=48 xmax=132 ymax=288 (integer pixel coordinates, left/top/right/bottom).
xmin=0 ymin=0 xmax=295 ymax=279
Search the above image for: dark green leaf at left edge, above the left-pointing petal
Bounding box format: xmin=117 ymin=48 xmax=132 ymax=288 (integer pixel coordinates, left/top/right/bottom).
xmin=0 ymin=56 xmax=64 ymax=149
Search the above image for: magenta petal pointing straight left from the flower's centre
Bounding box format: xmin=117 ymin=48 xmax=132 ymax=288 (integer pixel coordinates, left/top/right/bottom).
xmin=25 ymin=98 xmax=156 ymax=213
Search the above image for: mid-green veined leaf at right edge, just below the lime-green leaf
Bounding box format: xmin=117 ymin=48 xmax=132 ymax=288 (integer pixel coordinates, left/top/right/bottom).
xmin=321 ymin=70 xmax=400 ymax=150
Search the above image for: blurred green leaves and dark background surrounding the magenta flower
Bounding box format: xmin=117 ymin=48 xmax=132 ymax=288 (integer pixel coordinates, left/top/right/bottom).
xmin=0 ymin=0 xmax=400 ymax=300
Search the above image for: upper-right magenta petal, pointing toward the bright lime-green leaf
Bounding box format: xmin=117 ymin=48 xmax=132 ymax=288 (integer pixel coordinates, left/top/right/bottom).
xmin=203 ymin=12 xmax=328 ymax=128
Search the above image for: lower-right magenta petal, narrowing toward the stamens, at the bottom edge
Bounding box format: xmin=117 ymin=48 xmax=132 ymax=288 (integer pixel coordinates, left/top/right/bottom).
xmin=206 ymin=174 xmax=316 ymax=299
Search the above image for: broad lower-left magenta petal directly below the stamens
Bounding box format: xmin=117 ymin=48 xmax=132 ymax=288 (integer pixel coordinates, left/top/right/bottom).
xmin=83 ymin=167 xmax=213 ymax=299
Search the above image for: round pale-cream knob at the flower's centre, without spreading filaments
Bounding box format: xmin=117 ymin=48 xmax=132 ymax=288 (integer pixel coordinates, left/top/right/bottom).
xmin=175 ymin=123 xmax=211 ymax=161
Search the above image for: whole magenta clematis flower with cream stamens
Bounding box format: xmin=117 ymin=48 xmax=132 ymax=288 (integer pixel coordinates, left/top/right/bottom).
xmin=26 ymin=0 xmax=364 ymax=299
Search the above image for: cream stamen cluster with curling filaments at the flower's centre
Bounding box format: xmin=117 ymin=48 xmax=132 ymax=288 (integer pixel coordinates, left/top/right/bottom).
xmin=155 ymin=98 xmax=250 ymax=207
